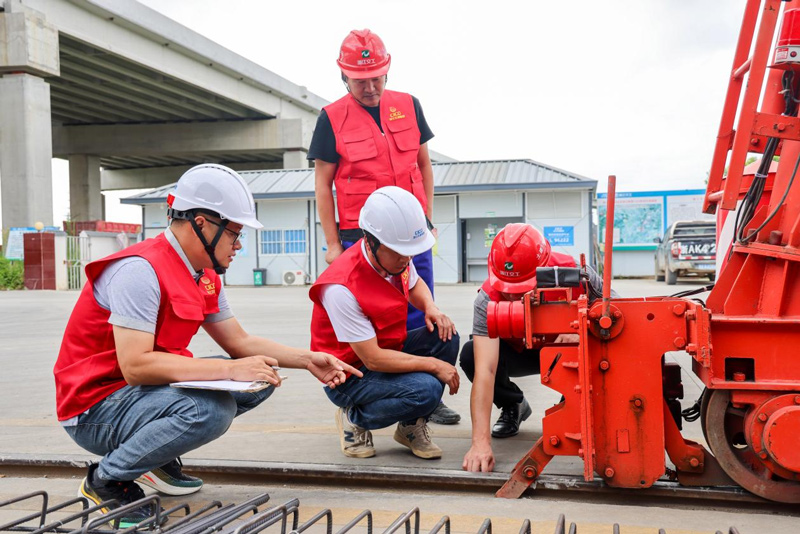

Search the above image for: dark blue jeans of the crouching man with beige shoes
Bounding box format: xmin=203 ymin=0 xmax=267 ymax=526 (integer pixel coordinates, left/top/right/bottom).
xmin=325 ymin=328 xmax=459 ymax=430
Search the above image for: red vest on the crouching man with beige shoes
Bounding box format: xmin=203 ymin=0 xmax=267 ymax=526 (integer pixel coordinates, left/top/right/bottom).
xmin=308 ymin=239 xmax=409 ymax=367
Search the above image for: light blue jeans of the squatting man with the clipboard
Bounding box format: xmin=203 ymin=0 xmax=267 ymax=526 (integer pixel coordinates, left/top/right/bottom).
xmin=64 ymin=386 xmax=275 ymax=480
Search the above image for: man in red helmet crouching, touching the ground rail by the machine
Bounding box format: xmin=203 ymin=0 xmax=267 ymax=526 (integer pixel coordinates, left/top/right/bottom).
xmin=460 ymin=223 xmax=603 ymax=471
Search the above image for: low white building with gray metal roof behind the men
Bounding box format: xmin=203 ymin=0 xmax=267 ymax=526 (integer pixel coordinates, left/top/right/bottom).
xmin=122 ymin=160 xmax=597 ymax=285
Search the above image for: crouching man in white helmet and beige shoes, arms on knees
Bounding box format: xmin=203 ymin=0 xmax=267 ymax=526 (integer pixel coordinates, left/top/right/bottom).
xmin=309 ymin=186 xmax=459 ymax=458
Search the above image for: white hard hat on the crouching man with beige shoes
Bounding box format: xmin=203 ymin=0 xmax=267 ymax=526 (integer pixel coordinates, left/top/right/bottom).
xmin=358 ymin=185 xmax=436 ymax=256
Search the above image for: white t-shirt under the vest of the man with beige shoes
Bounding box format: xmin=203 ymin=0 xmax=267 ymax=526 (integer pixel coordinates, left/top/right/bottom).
xmin=320 ymin=241 xmax=419 ymax=343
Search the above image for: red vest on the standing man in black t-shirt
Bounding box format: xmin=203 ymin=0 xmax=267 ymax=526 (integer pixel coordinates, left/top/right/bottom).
xmin=325 ymin=91 xmax=428 ymax=230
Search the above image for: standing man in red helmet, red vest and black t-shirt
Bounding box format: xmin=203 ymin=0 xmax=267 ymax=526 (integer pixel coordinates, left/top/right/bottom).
xmin=308 ymin=29 xmax=461 ymax=424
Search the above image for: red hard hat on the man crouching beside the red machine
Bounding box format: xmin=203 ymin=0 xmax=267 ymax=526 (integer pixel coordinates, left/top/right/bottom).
xmin=489 ymin=223 xmax=550 ymax=294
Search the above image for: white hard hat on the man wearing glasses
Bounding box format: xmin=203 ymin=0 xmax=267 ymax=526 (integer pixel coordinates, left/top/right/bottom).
xmin=170 ymin=163 xmax=264 ymax=230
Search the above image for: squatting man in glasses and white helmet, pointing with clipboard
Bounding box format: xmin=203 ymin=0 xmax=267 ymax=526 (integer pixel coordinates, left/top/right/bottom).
xmin=54 ymin=164 xmax=360 ymax=523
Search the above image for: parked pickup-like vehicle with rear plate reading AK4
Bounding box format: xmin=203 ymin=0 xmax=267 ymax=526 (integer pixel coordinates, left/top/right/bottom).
xmin=655 ymin=221 xmax=717 ymax=285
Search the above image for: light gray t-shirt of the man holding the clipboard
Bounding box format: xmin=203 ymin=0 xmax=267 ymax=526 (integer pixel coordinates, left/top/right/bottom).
xmin=94 ymin=228 xmax=233 ymax=334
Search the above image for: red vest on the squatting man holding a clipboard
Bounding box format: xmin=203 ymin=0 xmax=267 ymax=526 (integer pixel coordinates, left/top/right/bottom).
xmin=53 ymin=234 xmax=220 ymax=421
